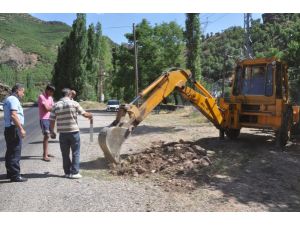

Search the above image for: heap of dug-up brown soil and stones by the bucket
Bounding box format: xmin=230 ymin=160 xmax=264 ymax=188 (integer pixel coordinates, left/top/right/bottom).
xmin=110 ymin=140 xmax=212 ymax=191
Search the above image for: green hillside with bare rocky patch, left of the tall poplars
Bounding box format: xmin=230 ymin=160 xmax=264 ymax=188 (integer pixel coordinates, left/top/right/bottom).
xmin=0 ymin=13 xmax=71 ymax=100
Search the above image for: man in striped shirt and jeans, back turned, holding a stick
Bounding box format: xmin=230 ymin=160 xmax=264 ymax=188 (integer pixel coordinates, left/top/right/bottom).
xmin=49 ymin=88 xmax=93 ymax=179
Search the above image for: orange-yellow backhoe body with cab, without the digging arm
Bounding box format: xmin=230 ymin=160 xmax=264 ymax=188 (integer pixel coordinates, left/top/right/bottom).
xmin=220 ymin=58 xmax=299 ymax=131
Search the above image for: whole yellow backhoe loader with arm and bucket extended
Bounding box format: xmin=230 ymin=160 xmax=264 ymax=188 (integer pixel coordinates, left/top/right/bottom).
xmin=98 ymin=58 xmax=300 ymax=163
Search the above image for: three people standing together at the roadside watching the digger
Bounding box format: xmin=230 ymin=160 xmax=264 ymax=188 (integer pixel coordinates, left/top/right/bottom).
xmin=3 ymin=84 xmax=93 ymax=182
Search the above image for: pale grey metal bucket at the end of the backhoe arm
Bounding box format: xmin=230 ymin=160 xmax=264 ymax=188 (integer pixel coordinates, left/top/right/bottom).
xmin=98 ymin=126 xmax=130 ymax=164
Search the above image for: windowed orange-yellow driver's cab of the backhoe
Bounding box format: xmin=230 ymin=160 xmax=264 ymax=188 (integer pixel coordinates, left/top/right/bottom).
xmin=231 ymin=58 xmax=288 ymax=103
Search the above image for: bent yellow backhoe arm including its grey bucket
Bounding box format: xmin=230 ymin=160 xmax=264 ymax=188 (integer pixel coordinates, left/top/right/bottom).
xmin=98 ymin=70 xmax=224 ymax=163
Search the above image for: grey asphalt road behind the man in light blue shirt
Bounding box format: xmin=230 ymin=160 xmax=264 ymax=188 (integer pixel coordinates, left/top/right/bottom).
xmin=0 ymin=107 xmax=42 ymax=157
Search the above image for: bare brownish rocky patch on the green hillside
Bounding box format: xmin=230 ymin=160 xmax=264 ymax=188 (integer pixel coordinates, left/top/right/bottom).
xmin=0 ymin=42 xmax=38 ymax=70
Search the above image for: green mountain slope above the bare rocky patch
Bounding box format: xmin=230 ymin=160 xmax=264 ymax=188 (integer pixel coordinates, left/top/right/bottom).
xmin=0 ymin=14 xmax=71 ymax=63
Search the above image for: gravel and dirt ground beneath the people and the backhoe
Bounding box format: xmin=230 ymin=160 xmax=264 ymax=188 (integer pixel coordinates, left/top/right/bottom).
xmin=0 ymin=106 xmax=300 ymax=212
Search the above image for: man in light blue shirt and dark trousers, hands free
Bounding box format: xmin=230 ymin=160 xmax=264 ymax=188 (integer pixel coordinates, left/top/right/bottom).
xmin=3 ymin=84 xmax=27 ymax=182
